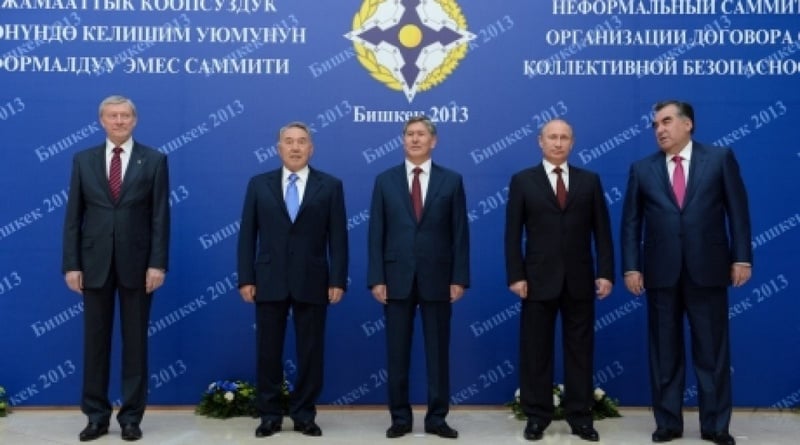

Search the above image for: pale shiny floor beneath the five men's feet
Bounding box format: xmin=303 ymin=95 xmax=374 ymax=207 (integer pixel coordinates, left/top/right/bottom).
xmin=0 ymin=407 xmax=800 ymax=445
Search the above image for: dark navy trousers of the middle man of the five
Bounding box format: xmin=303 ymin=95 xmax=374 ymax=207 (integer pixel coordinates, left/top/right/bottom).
xmin=384 ymin=286 xmax=453 ymax=427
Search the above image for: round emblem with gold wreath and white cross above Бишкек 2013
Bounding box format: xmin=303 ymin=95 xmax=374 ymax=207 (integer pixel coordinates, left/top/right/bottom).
xmin=345 ymin=0 xmax=475 ymax=103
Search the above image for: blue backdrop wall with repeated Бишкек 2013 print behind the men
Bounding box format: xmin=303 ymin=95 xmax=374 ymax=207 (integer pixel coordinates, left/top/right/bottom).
xmin=0 ymin=0 xmax=800 ymax=407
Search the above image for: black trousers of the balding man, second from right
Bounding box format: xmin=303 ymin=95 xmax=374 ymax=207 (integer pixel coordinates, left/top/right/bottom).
xmin=519 ymin=286 xmax=595 ymax=427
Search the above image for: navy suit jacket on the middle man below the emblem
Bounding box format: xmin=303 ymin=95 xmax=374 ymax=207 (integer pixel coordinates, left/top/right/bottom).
xmin=367 ymin=163 xmax=470 ymax=300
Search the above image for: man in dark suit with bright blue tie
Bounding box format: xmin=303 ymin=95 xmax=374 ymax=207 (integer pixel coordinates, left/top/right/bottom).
xmin=238 ymin=122 xmax=348 ymax=437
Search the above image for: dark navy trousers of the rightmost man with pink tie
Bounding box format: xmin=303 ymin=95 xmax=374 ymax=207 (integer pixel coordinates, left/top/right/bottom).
xmin=647 ymin=273 xmax=732 ymax=433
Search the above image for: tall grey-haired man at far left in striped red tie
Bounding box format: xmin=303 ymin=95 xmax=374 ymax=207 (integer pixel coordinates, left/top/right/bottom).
xmin=62 ymin=96 xmax=170 ymax=441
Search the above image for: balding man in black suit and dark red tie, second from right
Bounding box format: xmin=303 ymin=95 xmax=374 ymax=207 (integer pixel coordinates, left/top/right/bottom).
xmin=505 ymin=119 xmax=614 ymax=441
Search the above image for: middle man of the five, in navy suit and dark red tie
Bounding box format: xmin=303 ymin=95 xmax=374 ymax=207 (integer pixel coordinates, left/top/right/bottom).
xmin=367 ymin=116 xmax=469 ymax=438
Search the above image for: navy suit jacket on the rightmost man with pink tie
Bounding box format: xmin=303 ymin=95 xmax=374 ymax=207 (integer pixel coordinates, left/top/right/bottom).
xmin=622 ymin=142 xmax=753 ymax=288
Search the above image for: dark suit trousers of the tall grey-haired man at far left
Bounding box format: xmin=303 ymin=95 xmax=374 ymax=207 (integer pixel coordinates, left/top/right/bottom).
xmin=81 ymin=267 xmax=153 ymax=425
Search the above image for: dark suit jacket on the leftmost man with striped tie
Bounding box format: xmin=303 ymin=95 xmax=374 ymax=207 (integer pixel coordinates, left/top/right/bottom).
xmin=62 ymin=142 xmax=170 ymax=289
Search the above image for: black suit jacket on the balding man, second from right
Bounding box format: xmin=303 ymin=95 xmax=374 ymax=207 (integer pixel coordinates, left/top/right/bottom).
xmin=505 ymin=164 xmax=614 ymax=300
